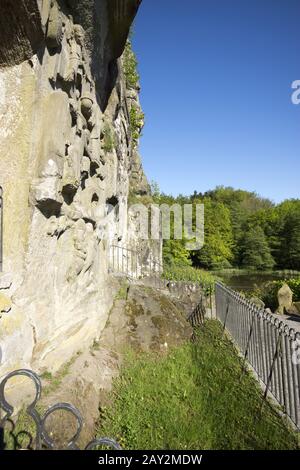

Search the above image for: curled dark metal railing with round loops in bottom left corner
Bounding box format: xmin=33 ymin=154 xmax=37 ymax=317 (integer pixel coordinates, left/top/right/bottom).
xmin=0 ymin=369 xmax=121 ymax=450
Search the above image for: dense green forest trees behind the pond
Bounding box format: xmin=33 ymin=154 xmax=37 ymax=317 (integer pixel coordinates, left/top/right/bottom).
xmin=152 ymin=184 xmax=300 ymax=270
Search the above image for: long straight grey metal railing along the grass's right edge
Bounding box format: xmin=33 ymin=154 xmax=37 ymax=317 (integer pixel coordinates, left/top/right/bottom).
xmin=216 ymin=283 xmax=300 ymax=429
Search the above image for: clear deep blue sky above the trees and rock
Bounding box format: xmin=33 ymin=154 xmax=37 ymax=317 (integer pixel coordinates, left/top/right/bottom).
xmin=133 ymin=0 xmax=300 ymax=202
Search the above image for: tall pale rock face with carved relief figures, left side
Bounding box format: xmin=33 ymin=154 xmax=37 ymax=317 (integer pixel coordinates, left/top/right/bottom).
xmin=0 ymin=0 xmax=160 ymax=376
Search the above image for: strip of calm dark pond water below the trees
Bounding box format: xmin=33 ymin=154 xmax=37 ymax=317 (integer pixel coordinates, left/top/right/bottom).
xmin=214 ymin=272 xmax=300 ymax=290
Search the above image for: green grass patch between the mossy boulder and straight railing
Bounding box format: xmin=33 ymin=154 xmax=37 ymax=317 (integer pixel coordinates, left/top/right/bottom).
xmin=98 ymin=320 xmax=297 ymax=450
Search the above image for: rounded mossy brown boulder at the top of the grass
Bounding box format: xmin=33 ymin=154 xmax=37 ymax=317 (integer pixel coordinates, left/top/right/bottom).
xmin=101 ymin=285 xmax=192 ymax=352
